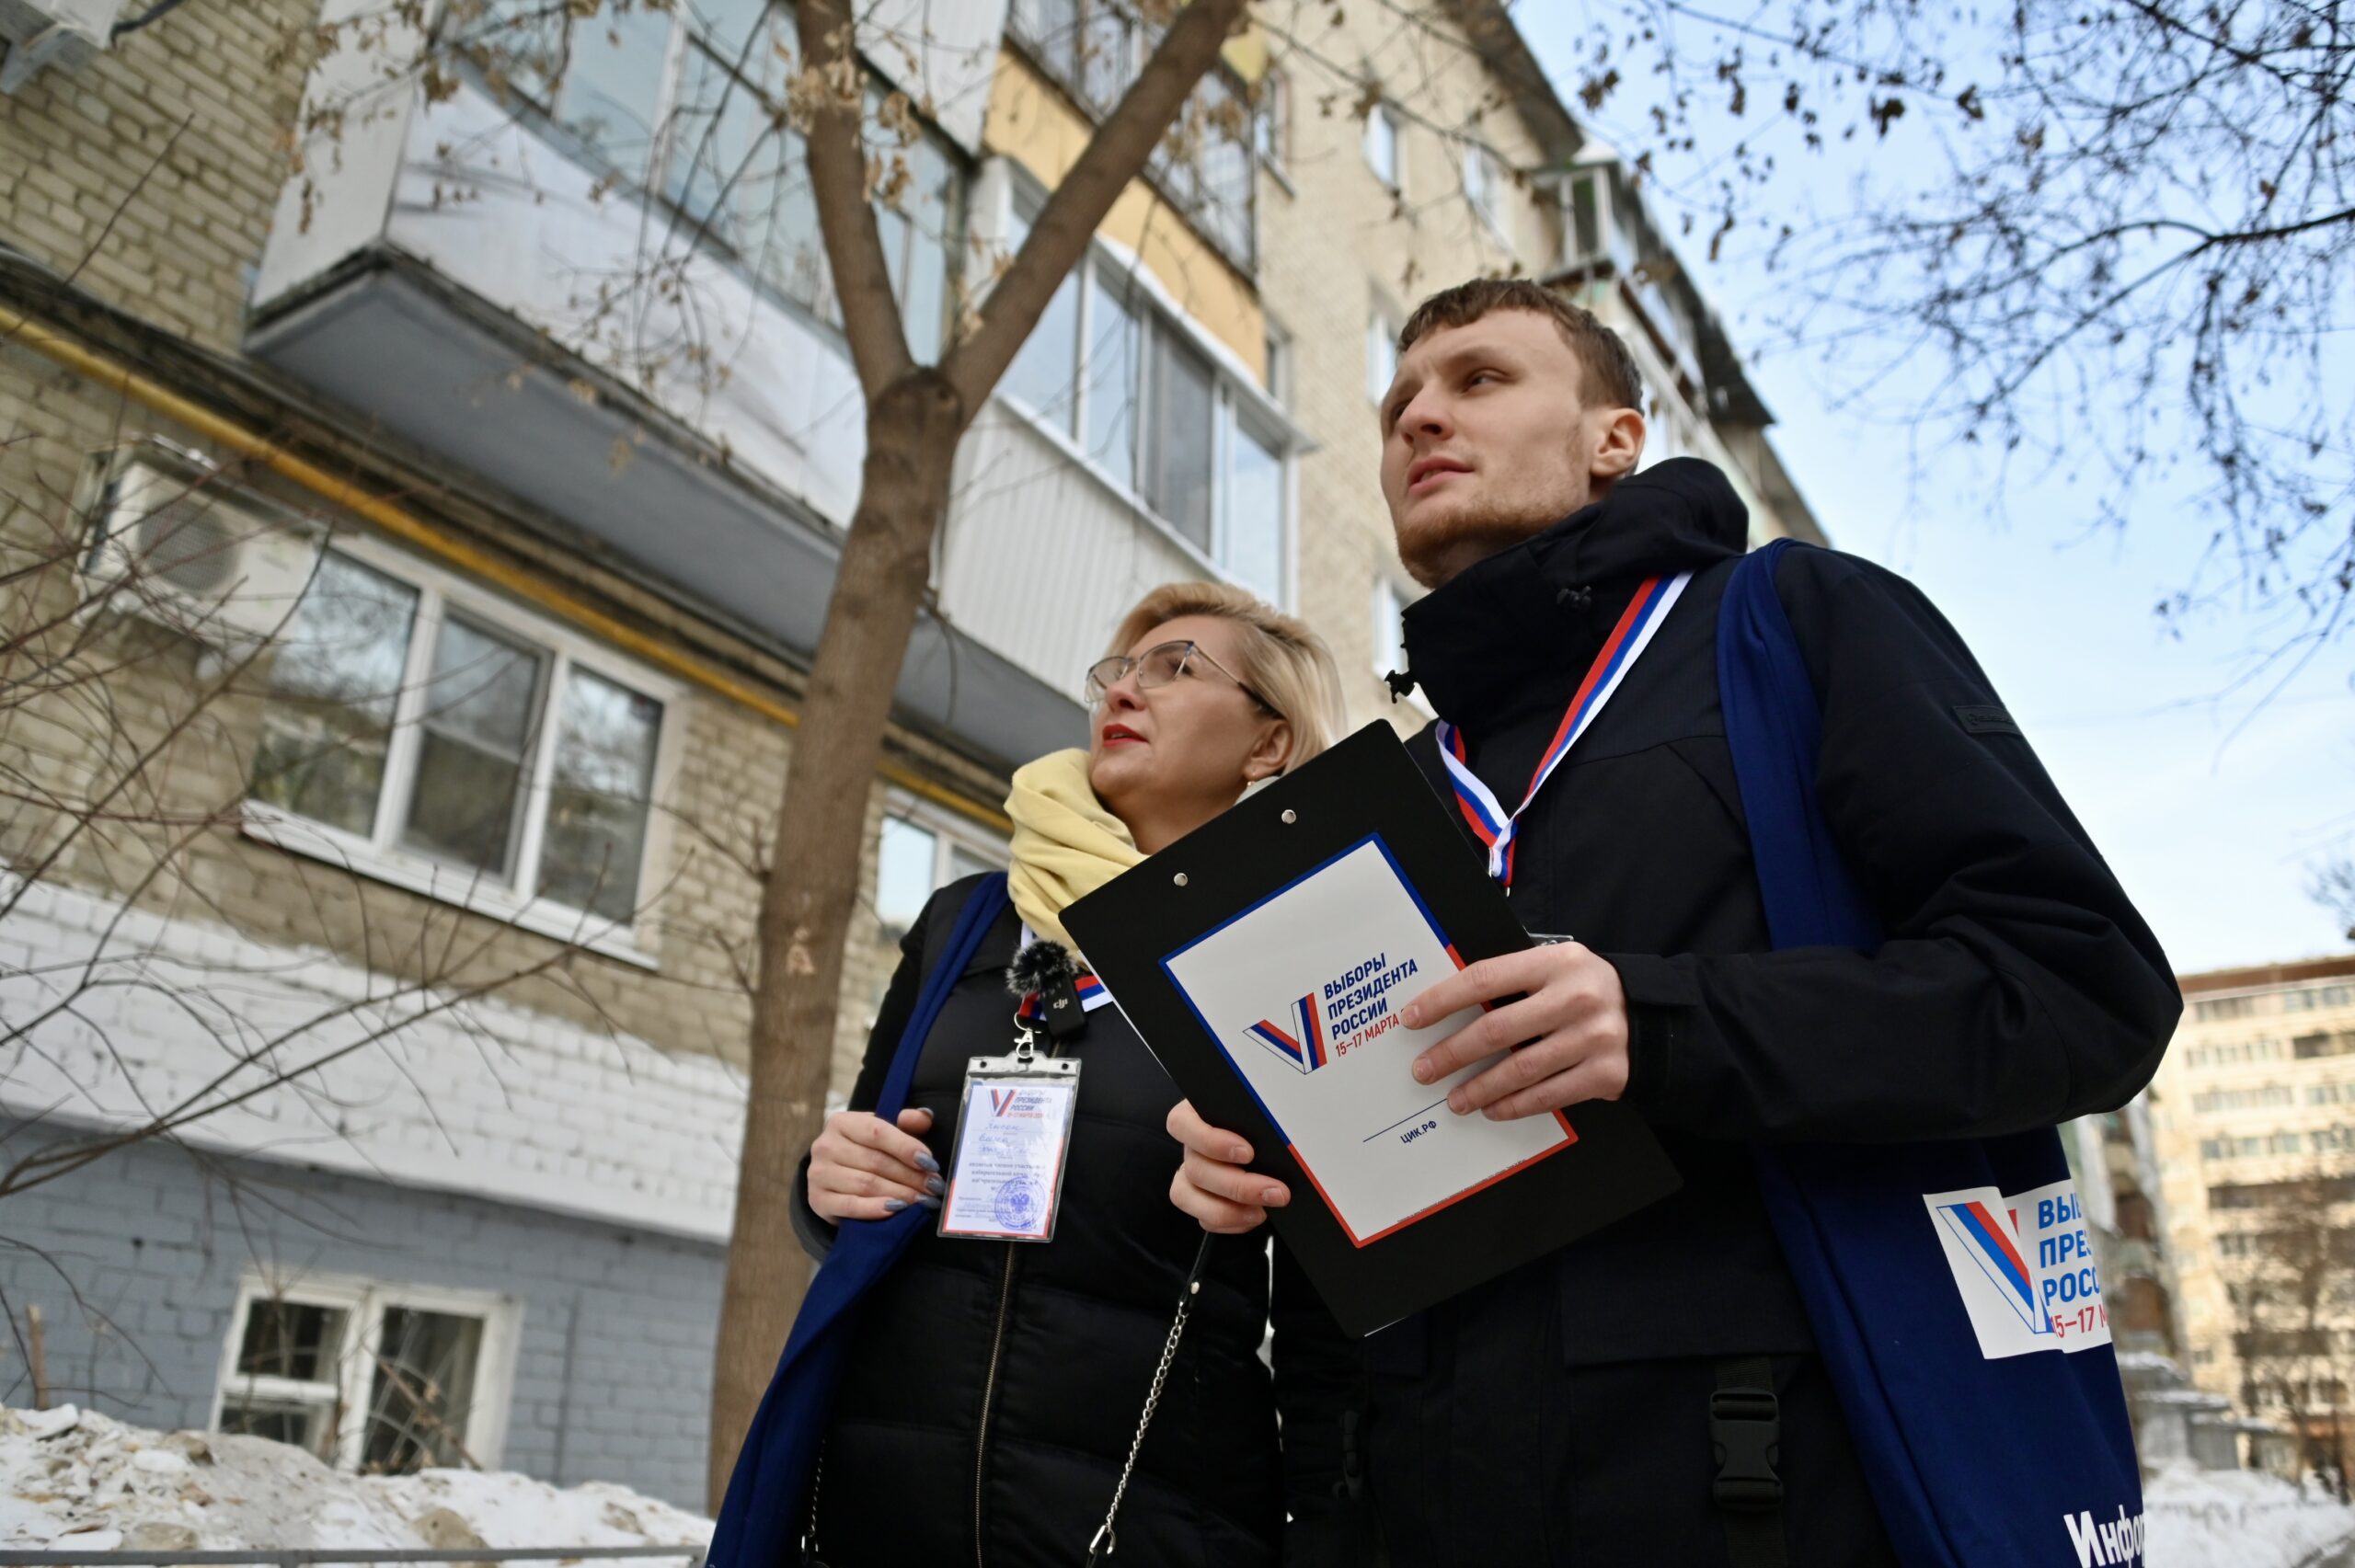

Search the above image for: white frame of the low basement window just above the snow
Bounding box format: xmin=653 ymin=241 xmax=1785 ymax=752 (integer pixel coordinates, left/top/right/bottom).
xmin=205 ymin=1269 xmax=523 ymax=1471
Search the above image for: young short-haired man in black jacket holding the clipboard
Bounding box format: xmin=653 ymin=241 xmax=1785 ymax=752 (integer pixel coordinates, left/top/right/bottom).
xmin=1170 ymin=282 xmax=2181 ymax=1568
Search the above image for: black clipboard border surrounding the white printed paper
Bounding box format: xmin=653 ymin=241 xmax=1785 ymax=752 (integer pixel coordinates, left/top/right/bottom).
xmin=1063 ymin=723 xmax=1682 ymax=1335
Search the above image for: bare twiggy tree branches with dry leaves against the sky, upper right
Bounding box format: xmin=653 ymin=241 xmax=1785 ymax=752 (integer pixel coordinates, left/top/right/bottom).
xmin=1578 ymin=0 xmax=2355 ymax=635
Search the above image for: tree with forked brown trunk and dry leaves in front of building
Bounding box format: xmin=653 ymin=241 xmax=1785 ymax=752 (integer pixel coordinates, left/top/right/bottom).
xmin=258 ymin=0 xmax=1545 ymax=1502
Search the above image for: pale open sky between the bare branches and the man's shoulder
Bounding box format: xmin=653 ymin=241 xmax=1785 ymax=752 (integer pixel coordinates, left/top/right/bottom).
xmin=1514 ymin=5 xmax=2355 ymax=972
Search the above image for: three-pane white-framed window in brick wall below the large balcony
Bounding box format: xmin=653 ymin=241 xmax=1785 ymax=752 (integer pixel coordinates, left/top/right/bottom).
xmin=247 ymin=542 xmax=666 ymax=937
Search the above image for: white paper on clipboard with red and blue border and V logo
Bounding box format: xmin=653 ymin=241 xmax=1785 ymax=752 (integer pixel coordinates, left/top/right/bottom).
xmin=1164 ymin=838 xmax=1578 ymax=1245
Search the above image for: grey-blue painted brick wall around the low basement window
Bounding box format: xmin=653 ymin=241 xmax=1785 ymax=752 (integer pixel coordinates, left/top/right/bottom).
xmin=0 ymin=1127 xmax=725 ymax=1512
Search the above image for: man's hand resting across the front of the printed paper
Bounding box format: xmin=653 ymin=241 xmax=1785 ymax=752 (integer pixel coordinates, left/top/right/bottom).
xmin=1394 ymin=942 xmax=1627 ymax=1116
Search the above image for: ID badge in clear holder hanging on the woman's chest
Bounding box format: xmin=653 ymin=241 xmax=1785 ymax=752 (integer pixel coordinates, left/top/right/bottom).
xmin=939 ymin=1055 xmax=1078 ymax=1241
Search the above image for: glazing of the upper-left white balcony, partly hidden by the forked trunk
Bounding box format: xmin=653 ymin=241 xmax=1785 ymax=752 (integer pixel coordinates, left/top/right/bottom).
xmin=471 ymin=0 xmax=966 ymax=362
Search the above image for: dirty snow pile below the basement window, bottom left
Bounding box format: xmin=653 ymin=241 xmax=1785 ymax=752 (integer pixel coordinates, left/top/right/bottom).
xmin=0 ymin=1405 xmax=711 ymax=1568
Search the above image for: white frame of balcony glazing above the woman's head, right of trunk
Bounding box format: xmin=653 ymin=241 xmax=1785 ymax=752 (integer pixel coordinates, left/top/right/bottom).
xmin=994 ymin=181 xmax=1312 ymax=607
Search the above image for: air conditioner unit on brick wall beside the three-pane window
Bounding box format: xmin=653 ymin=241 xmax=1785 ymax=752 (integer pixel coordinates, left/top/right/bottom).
xmin=85 ymin=457 xmax=318 ymax=647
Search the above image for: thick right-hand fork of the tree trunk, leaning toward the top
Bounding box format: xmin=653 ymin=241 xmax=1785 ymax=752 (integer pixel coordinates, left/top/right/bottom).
xmin=936 ymin=0 xmax=1244 ymax=417
